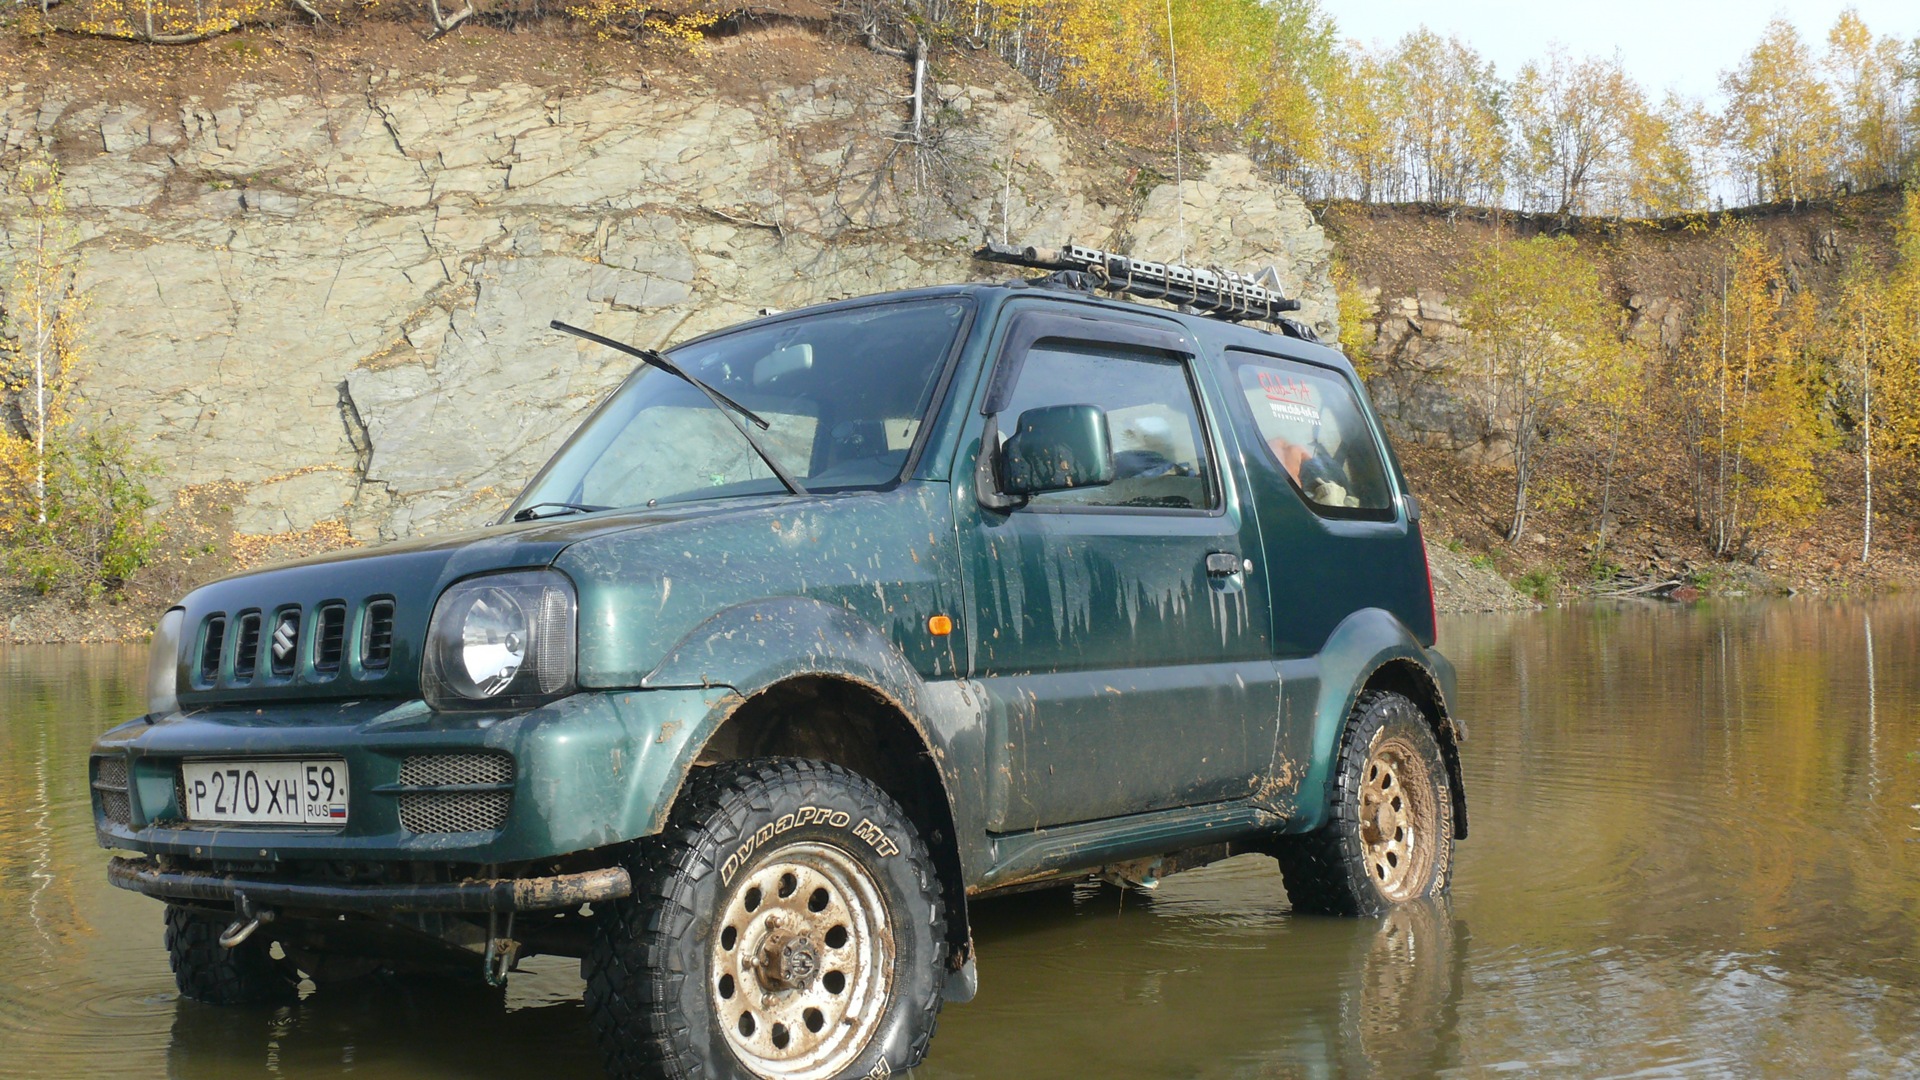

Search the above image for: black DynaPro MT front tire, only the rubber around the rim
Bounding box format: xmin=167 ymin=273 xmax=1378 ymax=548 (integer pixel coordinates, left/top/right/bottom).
xmin=582 ymin=757 xmax=948 ymax=1080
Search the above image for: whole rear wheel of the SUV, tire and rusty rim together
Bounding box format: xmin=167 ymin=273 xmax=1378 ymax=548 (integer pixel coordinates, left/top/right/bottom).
xmin=1273 ymin=690 xmax=1453 ymax=915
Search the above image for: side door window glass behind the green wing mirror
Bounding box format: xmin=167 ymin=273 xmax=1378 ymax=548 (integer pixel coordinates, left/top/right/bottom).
xmin=1000 ymin=342 xmax=1213 ymax=509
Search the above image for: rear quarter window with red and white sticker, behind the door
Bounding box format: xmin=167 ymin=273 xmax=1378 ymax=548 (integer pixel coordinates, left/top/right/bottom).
xmin=1227 ymin=352 xmax=1394 ymax=521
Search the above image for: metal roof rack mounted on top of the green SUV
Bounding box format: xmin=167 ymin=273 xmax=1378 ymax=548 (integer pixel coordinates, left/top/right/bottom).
xmin=973 ymin=242 xmax=1315 ymax=332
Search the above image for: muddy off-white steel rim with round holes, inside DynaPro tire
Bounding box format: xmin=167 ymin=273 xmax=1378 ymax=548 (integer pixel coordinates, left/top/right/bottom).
xmin=708 ymin=842 xmax=895 ymax=1080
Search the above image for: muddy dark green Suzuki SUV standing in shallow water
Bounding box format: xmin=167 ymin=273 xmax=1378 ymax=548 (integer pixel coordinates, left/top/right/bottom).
xmin=90 ymin=248 xmax=1467 ymax=1078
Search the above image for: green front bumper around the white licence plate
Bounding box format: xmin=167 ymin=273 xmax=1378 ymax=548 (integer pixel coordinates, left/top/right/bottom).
xmin=92 ymin=688 xmax=728 ymax=860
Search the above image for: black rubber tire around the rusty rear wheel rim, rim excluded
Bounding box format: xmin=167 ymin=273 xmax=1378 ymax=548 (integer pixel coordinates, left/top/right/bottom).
xmin=1273 ymin=690 xmax=1453 ymax=917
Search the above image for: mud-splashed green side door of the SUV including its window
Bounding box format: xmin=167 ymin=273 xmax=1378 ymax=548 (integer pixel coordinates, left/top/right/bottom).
xmin=954 ymin=307 xmax=1279 ymax=832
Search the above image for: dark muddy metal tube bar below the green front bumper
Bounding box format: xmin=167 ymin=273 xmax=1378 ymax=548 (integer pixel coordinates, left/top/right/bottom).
xmin=108 ymin=859 xmax=634 ymax=915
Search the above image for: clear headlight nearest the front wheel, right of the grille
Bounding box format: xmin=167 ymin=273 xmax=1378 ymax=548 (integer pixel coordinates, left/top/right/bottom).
xmin=432 ymin=571 xmax=574 ymax=709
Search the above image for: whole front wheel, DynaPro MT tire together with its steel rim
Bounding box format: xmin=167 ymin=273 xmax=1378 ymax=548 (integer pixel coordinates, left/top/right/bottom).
xmin=582 ymin=759 xmax=947 ymax=1080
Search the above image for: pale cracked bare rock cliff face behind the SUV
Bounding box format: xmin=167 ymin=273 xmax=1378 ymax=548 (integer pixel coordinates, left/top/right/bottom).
xmin=0 ymin=42 xmax=1334 ymax=540
